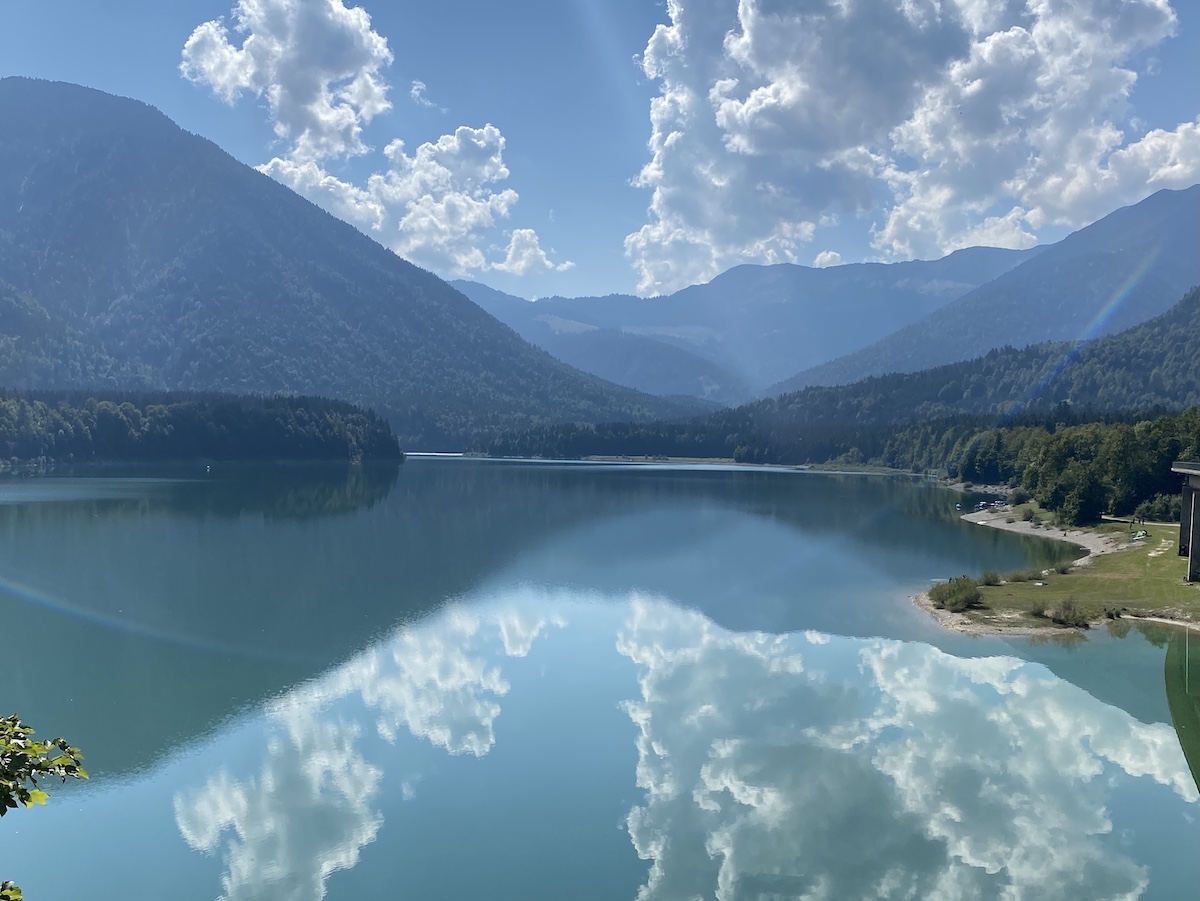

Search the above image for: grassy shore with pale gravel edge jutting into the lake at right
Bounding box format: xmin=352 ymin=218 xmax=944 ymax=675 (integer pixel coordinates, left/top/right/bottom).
xmin=917 ymin=509 xmax=1200 ymax=633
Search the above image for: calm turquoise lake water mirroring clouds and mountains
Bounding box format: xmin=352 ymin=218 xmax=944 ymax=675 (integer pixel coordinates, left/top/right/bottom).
xmin=0 ymin=459 xmax=1200 ymax=901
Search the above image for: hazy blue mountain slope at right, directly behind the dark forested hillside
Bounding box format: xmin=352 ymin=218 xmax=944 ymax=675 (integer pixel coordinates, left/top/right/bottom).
xmin=770 ymin=185 xmax=1200 ymax=392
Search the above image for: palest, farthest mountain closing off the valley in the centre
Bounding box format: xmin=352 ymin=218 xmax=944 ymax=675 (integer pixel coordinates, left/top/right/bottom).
xmin=466 ymin=247 xmax=1039 ymax=394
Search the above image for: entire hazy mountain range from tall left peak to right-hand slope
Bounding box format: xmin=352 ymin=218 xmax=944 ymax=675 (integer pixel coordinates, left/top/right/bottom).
xmin=0 ymin=78 xmax=1200 ymax=450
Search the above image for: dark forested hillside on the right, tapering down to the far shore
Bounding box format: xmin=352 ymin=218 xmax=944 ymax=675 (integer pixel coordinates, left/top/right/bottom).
xmin=487 ymin=288 xmax=1200 ymax=463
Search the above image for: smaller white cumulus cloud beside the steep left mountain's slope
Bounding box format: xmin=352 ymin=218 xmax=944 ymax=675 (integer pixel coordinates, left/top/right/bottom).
xmin=180 ymin=0 xmax=570 ymax=275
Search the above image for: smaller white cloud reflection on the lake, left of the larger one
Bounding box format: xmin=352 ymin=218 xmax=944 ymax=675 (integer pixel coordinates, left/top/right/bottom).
xmin=174 ymin=599 xmax=564 ymax=901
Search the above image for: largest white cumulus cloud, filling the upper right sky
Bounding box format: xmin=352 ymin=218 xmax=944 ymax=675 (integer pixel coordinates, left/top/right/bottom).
xmin=625 ymin=0 xmax=1200 ymax=292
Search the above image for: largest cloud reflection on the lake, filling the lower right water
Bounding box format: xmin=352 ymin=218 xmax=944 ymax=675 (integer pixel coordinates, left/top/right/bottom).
xmin=618 ymin=600 xmax=1196 ymax=901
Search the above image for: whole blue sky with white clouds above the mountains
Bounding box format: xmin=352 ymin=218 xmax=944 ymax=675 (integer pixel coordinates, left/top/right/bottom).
xmin=0 ymin=0 xmax=1200 ymax=296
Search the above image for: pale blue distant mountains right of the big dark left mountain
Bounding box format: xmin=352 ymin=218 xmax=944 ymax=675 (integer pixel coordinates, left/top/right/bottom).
xmin=455 ymin=186 xmax=1200 ymax=403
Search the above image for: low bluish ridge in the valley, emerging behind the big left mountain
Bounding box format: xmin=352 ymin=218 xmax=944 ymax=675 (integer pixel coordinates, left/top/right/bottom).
xmin=451 ymin=281 xmax=754 ymax=404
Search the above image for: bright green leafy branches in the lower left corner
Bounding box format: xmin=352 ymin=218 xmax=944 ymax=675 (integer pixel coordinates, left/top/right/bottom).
xmin=0 ymin=714 xmax=88 ymax=901
